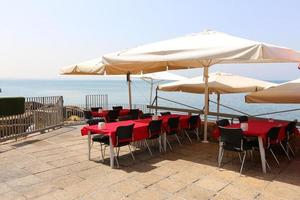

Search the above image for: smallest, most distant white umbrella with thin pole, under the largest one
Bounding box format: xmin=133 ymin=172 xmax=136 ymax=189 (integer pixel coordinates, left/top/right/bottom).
xmin=133 ymin=71 xmax=186 ymax=107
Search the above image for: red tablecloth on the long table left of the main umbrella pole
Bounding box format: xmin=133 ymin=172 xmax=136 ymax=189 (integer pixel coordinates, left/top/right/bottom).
xmin=81 ymin=115 xmax=196 ymax=145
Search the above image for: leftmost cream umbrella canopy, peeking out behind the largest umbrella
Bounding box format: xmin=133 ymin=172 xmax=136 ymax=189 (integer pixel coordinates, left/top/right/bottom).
xmin=61 ymin=57 xmax=105 ymax=75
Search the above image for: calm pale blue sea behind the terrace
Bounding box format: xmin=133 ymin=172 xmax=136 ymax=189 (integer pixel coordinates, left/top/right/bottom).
xmin=0 ymin=79 xmax=300 ymax=121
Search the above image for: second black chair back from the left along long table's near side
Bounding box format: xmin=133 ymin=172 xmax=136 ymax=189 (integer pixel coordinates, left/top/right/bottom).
xmin=145 ymin=120 xmax=162 ymax=156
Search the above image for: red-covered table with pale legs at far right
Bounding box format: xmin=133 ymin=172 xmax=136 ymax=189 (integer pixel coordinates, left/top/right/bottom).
xmin=212 ymin=119 xmax=288 ymax=173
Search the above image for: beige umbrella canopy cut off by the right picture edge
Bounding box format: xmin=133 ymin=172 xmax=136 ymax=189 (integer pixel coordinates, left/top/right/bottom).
xmin=245 ymin=79 xmax=300 ymax=103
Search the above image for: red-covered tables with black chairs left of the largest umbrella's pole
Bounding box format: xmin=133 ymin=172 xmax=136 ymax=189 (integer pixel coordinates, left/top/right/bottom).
xmin=81 ymin=106 xmax=201 ymax=167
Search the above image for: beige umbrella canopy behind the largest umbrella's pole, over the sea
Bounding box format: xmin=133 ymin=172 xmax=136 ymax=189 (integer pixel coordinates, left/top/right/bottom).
xmin=158 ymin=72 xmax=276 ymax=94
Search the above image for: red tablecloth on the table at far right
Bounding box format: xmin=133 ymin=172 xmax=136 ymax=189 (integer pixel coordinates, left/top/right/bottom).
xmin=212 ymin=119 xmax=288 ymax=139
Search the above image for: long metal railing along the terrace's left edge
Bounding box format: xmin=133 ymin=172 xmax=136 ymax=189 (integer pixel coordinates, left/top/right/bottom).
xmin=0 ymin=96 xmax=64 ymax=141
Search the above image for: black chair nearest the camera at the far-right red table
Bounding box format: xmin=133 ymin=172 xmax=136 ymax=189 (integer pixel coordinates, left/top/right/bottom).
xmin=218 ymin=127 xmax=253 ymax=173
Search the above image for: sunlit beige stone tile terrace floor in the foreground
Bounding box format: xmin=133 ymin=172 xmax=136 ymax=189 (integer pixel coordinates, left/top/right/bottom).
xmin=0 ymin=126 xmax=300 ymax=200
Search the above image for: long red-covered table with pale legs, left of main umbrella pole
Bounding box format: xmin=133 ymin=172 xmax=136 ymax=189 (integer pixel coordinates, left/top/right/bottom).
xmin=81 ymin=114 xmax=195 ymax=168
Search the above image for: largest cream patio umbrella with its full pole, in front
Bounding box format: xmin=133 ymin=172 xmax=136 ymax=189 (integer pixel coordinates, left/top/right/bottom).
xmin=103 ymin=31 xmax=300 ymax=142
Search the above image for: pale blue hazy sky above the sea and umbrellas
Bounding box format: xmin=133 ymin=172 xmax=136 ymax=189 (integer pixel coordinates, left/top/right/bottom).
xmin=0 ymin=0 xmax=300 ymax=80
